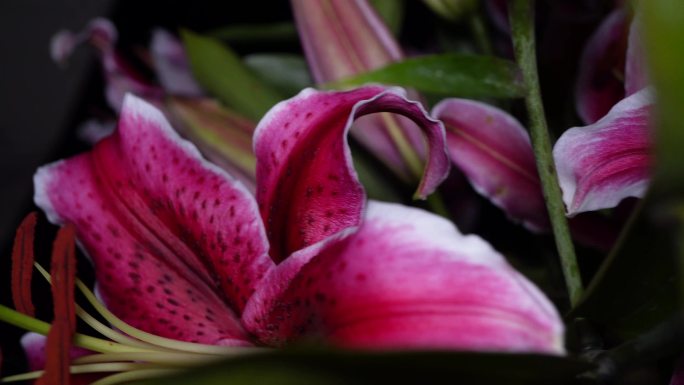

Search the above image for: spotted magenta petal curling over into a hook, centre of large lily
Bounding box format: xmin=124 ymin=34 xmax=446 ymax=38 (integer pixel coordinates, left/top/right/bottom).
xmin=254 ymin=86 xmax=449 ymax=261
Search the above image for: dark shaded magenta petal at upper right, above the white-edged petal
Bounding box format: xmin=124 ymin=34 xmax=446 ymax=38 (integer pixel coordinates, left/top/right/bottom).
xmin=575 ymin=8 xmax=628 ymax=124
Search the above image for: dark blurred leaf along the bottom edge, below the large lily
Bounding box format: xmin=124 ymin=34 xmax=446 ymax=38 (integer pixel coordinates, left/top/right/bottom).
xmin=134 ymin=349 xmax=592 ymax=385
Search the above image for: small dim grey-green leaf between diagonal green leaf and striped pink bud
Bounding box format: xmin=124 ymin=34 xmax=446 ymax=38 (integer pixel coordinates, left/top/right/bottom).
xmin=245 ymin=53 xmax=313 ymax=97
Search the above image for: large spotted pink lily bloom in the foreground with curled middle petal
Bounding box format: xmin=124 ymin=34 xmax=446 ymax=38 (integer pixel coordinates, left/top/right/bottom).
xmin=30 ymin=86 xmax=563 ymax=354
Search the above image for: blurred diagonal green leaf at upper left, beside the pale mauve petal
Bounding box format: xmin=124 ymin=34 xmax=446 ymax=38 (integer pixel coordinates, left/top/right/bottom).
xmin=181 ymin=30 xmax=284 ymax=120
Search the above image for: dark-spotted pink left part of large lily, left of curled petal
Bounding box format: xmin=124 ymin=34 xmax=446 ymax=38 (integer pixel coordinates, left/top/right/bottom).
xmin=34 ymin=96 xmax=273 ymax=344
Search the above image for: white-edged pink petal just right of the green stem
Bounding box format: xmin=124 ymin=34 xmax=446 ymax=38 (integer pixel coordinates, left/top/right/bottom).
xmin=553 ymin=88 xmax=653 ymax=215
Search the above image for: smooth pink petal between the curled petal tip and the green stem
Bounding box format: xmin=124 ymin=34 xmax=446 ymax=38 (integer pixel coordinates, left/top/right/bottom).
xmin=432 ymin=99 xmax=549 ymax=230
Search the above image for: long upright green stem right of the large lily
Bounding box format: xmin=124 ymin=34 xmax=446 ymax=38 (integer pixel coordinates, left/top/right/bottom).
xmin=509 ymin=0 xmax=583 ymax=306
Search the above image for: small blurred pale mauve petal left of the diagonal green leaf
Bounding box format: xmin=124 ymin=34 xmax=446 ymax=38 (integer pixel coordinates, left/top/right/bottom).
xmin=150 ymin=29 xmax=204 ymax=97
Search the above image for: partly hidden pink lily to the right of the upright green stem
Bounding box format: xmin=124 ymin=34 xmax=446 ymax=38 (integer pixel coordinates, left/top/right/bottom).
xmin=553 ymin=9 xmax=654 ymax=216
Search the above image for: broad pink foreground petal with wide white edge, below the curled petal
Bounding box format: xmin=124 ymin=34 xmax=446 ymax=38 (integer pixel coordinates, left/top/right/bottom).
xmin=243 ymin=202 xmax=563 ymax=354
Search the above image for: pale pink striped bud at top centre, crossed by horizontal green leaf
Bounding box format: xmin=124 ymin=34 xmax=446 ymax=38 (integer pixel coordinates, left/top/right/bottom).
xmin=291 ymin=0 xmax=425 ymax=180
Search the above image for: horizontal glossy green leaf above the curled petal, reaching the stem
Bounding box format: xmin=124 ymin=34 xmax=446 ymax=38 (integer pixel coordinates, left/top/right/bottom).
xmin=328 ymin=53 xmax=524 ymax=98
